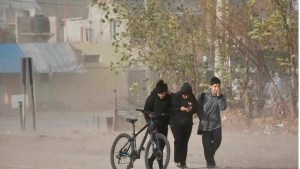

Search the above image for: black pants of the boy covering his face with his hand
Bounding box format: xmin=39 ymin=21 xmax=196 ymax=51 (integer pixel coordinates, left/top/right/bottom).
xmin=202 ymin=128 xmax=222 ymax=165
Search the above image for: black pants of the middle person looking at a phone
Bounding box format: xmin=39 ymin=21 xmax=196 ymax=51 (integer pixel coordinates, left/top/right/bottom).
xmin=171 ymin=125 xmax=193 ymax=165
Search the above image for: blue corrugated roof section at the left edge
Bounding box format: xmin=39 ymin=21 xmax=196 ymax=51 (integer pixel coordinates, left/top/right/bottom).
xmin=0 ymin=44 xmax=25 ymax=73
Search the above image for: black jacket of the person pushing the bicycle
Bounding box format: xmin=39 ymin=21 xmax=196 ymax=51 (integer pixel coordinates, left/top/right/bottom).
xmin=144 ymin=90 xmax=171 ymax=125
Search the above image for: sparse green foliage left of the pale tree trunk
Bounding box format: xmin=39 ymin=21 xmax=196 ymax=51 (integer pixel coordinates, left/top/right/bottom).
xmin=97 ymin=0 xmax=204 ymax=92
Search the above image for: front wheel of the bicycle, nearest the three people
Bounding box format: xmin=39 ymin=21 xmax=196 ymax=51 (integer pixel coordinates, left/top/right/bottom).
xmin=145 ymin=133 xmax=171 ymax=169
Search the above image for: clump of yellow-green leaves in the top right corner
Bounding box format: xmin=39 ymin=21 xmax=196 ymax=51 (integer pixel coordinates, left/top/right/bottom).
xmin=248 ymin=0 xmax=298 ymax=77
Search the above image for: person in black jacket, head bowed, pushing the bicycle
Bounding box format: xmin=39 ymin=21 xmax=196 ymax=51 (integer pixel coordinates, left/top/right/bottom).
xmin=144 ymin=80 xmax=171 ymax=168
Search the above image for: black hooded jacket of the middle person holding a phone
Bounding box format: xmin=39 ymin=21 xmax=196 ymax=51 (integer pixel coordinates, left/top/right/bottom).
xmin=170 ymin=83 xmax=198 ymax=126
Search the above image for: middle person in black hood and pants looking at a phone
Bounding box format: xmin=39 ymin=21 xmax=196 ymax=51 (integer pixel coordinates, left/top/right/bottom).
xmin=170 ymin=82 xmax=198 ymax=168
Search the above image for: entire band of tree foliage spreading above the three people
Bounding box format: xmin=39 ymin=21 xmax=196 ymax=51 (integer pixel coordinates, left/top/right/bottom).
xmin=100 ymin=0 xmax=298 ymax=107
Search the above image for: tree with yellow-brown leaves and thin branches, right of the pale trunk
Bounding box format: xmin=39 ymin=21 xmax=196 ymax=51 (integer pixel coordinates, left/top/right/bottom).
xmin=211 ymin=0 xmax=298 ymax=117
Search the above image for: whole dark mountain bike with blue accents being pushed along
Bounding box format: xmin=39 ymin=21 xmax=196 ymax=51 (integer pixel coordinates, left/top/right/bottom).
xmin=111 ymin=109 xmax=170 ymax=169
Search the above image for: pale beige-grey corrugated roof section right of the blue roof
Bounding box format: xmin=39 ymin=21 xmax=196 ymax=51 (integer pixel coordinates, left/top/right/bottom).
xmin=19 ymin=43 xmax=84 ymax=73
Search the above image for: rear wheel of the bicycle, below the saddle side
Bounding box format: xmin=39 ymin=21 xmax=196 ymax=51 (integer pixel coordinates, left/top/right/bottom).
xmin=110 ymin=133 xmax=133 ymax=169
